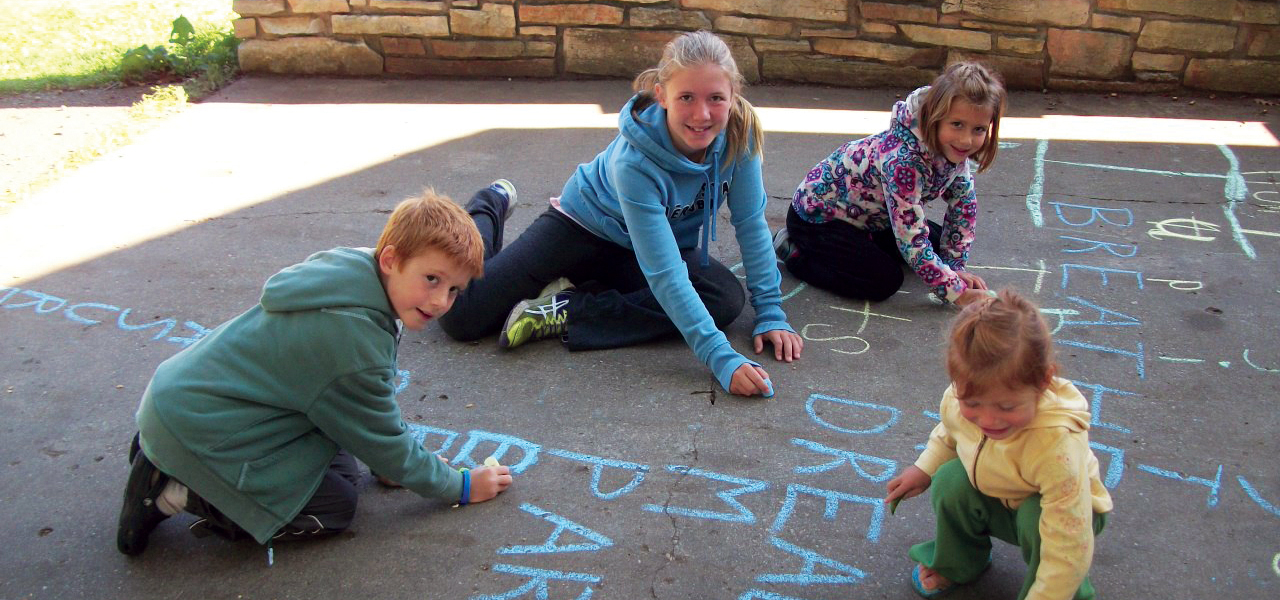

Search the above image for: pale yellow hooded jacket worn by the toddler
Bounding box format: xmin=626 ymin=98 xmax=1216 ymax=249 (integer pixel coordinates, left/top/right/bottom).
xmin=915 ymin=377 xmax=1112 ymax=600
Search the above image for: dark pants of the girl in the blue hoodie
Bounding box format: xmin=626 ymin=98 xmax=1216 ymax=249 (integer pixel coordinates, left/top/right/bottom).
xmin=440 ymin=189 xmax=746 ymax=351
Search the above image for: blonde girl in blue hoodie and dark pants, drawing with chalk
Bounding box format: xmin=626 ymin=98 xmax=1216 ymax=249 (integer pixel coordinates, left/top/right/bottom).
xmin=440 ymin=31 xmax=804 ymax=395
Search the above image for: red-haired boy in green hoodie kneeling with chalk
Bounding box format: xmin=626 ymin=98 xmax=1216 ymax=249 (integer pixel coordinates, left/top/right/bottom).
xmin=116 ymin=180 xmax=515 ymax=555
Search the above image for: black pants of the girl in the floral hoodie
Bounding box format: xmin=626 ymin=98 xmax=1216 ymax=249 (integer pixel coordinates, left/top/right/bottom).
xmin=786 ymin=209 xmax=942 ymax=302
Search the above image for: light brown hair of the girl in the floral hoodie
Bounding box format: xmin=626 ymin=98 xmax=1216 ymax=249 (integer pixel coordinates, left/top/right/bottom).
xmin=919 ymin=63 xmax=1009 ymax=173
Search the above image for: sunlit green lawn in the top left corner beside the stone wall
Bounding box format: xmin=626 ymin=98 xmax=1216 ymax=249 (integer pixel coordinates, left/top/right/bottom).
xmin=0 ymin=0 xmax=236 ymax=97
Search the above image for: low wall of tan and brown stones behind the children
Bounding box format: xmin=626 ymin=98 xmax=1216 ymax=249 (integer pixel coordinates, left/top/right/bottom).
xmin=232 ymin=0 xmax=1280 ymax=93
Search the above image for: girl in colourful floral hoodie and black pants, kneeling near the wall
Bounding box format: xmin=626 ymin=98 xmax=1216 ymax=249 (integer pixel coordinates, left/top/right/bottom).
xmin=773 ymin=63 xmax=1005 ymax=306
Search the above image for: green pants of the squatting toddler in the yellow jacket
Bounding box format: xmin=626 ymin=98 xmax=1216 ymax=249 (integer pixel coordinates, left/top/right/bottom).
xmin=909 ymin=458 xmax=1107 ymax=600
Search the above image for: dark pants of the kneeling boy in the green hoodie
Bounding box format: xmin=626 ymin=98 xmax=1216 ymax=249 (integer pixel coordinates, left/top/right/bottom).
xmin=184 ymin=450 xmax=361 ymax=541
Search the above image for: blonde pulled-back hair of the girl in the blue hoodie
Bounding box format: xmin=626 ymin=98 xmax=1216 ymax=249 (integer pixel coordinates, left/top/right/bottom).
xmin=631 ymin=31 xmax=764 ymax=162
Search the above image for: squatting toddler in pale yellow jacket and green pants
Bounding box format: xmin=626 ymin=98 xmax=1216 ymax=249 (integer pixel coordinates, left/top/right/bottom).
xmin=884 ymin=290 xmax=1111 ymax=600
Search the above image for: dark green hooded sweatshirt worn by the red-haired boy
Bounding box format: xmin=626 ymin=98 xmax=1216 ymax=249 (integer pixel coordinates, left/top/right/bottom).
xmin=137 ymin=248 xmax=462 ymax=544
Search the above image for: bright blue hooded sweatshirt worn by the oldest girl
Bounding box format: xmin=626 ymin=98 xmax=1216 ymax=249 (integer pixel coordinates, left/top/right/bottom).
xmin=561 ymin=96 xmax=795 ymax=390
